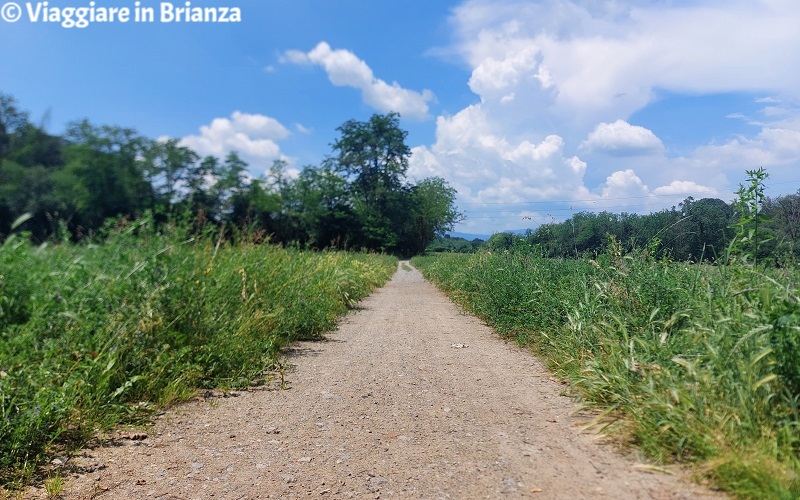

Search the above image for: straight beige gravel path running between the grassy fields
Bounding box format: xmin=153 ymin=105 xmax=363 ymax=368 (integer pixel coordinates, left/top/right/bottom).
xmin=56 ymin=267 xmax=720 ymax=499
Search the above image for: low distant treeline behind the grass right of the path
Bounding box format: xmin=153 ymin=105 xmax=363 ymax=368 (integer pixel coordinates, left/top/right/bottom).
xmin=488 ymin=191 xmax=800 ymax=262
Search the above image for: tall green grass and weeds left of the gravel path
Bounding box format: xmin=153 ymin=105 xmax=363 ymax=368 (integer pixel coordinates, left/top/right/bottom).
xmin=0 ymin=221 xmax=397 ymax=484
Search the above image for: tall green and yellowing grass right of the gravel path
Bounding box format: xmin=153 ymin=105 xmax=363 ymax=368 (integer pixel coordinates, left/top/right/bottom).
xmin=413 ymin=246 xmax=800 ymax=498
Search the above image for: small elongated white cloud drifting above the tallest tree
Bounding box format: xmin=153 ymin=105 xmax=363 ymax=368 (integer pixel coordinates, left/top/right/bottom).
xmin=281 ymin=42 xmax=434 ymax=120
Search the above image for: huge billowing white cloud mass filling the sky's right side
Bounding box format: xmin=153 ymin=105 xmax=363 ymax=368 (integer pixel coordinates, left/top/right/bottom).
xmin=410 ymin=0 xmax=800 ymax=232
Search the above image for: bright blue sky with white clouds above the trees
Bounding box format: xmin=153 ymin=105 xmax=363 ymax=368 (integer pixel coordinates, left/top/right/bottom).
xmin=0 ymin=0 xmax=800 ymax=234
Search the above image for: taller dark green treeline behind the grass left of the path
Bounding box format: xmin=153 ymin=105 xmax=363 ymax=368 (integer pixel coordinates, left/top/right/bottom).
xmin=0 ymin=93 xmax=460 ymax=255
